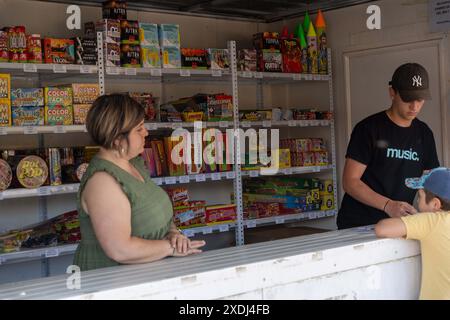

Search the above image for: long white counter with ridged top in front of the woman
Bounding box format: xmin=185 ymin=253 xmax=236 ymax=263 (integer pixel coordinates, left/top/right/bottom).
xmin=0 ymin=228 xmax=421 ymax=300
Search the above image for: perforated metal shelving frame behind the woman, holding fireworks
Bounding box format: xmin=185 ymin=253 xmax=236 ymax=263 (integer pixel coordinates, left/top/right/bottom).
xmin=0 ymin=40 xmax=337 ymax=264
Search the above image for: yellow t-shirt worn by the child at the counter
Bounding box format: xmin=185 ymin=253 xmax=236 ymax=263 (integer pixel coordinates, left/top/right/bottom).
xmin=401 ymin=211 xmax=450 ymax=300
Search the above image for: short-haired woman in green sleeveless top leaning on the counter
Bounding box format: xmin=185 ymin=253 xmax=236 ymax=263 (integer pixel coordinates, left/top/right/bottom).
xmin=74 ymin=94 xmax=205 ymax=271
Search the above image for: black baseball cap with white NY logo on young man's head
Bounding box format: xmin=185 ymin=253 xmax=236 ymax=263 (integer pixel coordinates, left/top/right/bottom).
xmin=389 ymin=63 xmax=431 ymax=102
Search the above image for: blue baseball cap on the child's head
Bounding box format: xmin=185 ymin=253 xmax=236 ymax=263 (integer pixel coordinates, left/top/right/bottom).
xmin=405 ymin=167 xmax=450 ymax=201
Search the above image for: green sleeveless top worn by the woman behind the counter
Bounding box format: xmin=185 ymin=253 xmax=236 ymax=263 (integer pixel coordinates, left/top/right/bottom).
xmin=74 ymin=157 xmax=173 ymax=271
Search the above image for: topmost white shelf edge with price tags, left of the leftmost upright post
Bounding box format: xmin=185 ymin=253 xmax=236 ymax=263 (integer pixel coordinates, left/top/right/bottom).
xmin=0 ymin=62 xmax=97 ymax=74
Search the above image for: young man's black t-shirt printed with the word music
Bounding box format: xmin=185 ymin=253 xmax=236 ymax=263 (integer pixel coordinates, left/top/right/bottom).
xmin=337 ymin=111 xmax=439 ymax=229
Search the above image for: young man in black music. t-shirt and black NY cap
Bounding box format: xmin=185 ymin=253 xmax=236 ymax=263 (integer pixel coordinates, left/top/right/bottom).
xmin=337 ymin=63 xmax=439 ymax=229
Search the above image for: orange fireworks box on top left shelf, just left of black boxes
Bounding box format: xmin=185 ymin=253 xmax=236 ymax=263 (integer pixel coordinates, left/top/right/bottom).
xmin=43 ymin=38 xmax=75 ymax=64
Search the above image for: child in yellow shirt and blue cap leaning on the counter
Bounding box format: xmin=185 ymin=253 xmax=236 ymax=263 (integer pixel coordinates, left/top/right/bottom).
xmin=375 ymin=167 xmax=450 ymax=300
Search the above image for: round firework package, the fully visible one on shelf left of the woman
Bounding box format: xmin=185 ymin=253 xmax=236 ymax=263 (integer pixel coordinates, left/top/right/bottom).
xmin=16 ymin=156 xmax=48 ymax=189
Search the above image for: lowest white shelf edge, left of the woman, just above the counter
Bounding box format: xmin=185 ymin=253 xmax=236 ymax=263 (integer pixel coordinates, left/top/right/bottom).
xmin=0 ymin=244 xmax=78 ymax=265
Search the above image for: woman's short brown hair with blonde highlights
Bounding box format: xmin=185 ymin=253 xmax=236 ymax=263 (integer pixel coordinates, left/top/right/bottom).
xmin=86 ymin=93 xmax=145 ymax=149
